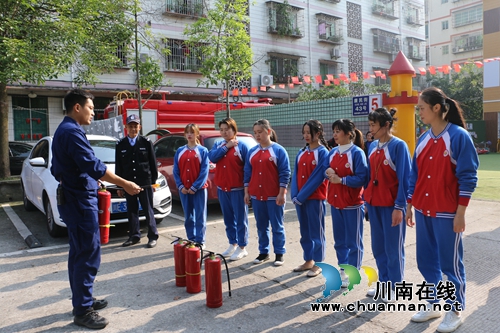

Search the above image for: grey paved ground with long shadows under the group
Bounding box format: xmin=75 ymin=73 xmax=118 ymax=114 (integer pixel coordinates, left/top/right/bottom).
xmin=0 ymin=200 xmax=500 ymax=332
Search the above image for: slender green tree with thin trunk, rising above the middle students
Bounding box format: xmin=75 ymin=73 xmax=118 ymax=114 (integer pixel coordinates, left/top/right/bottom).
xmin=184 ymin=0 xmax=253 ymax=116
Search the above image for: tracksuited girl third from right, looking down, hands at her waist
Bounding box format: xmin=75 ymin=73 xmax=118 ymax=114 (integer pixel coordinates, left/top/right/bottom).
xmin=324 ymin=119 xmax=368 ymax=288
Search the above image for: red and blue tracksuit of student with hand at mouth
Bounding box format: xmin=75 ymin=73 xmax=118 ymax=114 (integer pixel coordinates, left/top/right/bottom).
xmin=208 ymin=140 xmax=248 ymax=247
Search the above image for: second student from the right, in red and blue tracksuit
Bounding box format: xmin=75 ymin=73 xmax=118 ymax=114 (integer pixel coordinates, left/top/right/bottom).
xmin=364 ymin=108 xmax=411 ymax=302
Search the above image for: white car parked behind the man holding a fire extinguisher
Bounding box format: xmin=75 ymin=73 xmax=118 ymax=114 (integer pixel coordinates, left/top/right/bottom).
xmin=21 ymin=135 xmax=172 ymax=237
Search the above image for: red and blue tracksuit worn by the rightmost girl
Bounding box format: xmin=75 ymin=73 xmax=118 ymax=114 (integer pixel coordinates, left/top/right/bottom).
xmin=408 ymin=123 xmax=479 ymax=309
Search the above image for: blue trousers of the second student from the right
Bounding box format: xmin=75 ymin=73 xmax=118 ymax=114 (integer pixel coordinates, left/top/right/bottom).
xmin=366 ymin=204 xmax=406 ymax=288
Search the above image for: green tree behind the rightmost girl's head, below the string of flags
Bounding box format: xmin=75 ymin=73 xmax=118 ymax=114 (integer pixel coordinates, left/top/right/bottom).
xmin=427 ymin=63 xmax=483 ymax=120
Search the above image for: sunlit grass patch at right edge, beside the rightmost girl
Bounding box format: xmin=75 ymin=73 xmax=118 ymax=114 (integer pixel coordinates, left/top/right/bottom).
xmin=472 ymin=153 xmax=500 ymax=201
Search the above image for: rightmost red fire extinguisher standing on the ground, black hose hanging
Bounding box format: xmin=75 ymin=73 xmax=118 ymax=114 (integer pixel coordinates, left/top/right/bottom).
xmin=204 ymin=252 xmax=231 ymax=308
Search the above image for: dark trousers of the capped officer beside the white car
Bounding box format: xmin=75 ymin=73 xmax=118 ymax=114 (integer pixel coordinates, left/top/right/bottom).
xmin=125 ymin=186 xmax=158 ymax=241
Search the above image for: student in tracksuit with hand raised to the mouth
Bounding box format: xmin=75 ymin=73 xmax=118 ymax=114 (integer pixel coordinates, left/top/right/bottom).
xmin=208 ymin=118 xmax=248 ymax=260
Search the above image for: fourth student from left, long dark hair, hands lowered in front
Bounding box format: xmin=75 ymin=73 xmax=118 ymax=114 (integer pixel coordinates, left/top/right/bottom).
xmin=291 ymin=119 xmax=328 ymax=277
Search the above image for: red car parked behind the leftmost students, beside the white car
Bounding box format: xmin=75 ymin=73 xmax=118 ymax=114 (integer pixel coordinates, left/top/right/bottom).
xmin=153 ymin=130 xmax=257 ymax=203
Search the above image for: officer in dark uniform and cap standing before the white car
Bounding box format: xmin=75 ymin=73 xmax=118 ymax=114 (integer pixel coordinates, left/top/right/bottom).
xmin=115 ymin=114 xmax=158 ymax=248
